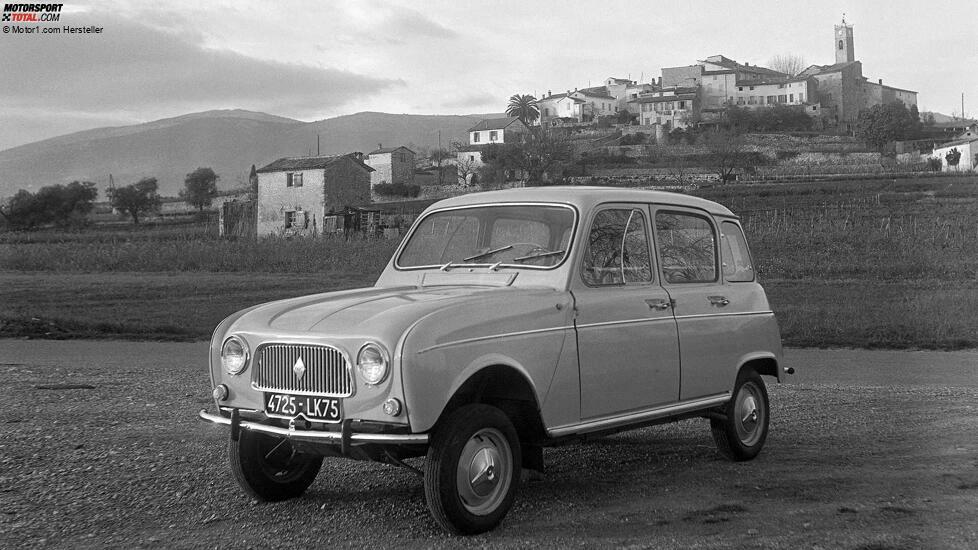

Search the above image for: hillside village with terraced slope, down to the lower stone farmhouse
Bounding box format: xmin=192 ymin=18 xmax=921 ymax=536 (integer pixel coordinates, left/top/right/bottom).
xmin=221 ymin=19 xmax=978 ymax=239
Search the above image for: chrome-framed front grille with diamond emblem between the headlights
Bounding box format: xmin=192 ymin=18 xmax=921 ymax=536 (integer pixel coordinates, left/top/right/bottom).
xmin=252 ymin=344 xmax=353 ymax=397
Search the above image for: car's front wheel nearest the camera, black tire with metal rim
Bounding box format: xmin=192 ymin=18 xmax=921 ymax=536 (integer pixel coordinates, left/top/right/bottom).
xmin=424 ymin=405 xmax=521 ymax=535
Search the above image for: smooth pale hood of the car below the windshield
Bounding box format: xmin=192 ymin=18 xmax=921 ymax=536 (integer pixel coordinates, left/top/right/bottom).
xmin=228 ymin=286 xmax=555 ymax=336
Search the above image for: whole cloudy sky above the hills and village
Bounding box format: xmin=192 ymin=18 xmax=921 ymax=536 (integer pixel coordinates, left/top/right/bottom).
xmin=0 ymin=0 xmax=978 ymax=150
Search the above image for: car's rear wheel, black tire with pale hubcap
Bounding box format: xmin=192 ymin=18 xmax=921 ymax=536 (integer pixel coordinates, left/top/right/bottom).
xmin=710 ymin=370 xmax=771 ymax=462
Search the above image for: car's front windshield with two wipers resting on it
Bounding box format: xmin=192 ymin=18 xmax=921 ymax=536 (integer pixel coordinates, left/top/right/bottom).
xmin=396 ymin=204 xmax=575 ymax=269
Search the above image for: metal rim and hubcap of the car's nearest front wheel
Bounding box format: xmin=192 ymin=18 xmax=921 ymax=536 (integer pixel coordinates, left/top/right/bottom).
xmin=456 ymin=428 xmax=513 ymax=515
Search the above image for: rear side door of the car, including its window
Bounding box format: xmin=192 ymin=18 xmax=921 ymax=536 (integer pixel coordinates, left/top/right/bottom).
xmin=653 ymin=206 xmax=753 ymax=400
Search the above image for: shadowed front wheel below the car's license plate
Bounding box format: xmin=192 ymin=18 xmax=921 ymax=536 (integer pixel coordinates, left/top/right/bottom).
xmin=228 ymin=430 xmax=323 ymax=502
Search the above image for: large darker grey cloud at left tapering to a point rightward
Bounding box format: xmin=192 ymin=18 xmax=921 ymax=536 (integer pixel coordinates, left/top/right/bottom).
xmin=0 ymin=13 xmax=404 ymax=116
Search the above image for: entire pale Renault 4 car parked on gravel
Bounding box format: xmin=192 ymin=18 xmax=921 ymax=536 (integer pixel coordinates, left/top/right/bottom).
xmin=200 ymin=187 xmax=790 ymax=534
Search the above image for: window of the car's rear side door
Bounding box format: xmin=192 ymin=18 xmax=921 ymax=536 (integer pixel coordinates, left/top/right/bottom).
xmin=655 ymin=211 xmax=719 ymax=284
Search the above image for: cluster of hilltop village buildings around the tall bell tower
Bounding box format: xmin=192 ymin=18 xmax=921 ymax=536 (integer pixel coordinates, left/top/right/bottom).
xmin=537 ymin=19 xmax=917 ymax=131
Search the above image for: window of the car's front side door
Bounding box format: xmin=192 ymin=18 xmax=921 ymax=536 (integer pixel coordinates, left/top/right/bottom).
xmin=582 ymin=208 xmax=652 ymax=286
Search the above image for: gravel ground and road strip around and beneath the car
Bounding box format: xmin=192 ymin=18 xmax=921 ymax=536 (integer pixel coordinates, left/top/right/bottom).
xmin=0 ymin=340 xmax=978 ymax=550
